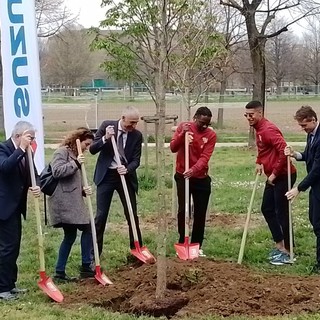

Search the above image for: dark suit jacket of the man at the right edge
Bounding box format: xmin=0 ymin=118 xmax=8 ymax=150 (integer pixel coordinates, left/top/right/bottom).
xmin=298 ymin=126 xmax=320 ymax=191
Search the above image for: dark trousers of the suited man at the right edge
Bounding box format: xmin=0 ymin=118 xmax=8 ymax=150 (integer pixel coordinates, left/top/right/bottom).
xmin=309 ymin=187 xmax=320 ymax=266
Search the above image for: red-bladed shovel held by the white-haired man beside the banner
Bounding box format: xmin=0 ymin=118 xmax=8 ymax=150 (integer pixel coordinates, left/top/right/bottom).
xmin=27 ymin=147 xmax=63 ymax=302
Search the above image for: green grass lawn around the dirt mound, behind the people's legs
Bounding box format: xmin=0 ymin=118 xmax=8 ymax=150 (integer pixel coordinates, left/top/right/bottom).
xmin=0 ymin=148 xmax=319 ymax=320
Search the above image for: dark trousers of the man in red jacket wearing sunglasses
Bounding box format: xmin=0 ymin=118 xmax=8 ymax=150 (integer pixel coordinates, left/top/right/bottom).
xmin=261 ymin=173 xmax=297 ymax=250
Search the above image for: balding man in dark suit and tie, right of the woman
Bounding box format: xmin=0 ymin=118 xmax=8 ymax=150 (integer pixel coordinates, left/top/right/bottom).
xmin=89 ymin=107 xmax=142 ymax=255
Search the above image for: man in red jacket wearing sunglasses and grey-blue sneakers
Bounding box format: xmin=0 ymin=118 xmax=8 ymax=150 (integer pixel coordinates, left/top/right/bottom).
xmin=244 ymin=101 xmax=297 ymax=265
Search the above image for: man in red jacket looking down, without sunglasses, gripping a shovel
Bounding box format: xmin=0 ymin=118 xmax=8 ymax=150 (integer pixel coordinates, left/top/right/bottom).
xmin=170 ymin=107 xmax=217 ymax=256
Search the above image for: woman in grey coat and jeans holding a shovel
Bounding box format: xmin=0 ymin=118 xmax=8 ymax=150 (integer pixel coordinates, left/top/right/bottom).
xmin=48 ymin=128 xmax=94 ymax=281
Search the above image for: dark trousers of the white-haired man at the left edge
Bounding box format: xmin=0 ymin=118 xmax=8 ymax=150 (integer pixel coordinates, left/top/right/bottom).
xmin=0 ymin=212 xmax=21 ymax=292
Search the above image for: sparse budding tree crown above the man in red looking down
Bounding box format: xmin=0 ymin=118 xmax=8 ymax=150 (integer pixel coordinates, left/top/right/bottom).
xmin=169 ymin=2 xmax=225 ymax=121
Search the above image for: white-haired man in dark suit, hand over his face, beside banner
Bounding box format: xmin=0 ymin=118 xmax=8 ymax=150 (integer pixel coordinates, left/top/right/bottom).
xmin=0 ymin=121 xmax=40 ymax=300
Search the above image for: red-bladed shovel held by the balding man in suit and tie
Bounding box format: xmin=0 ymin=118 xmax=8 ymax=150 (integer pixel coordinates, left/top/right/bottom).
xmin=111 ymin=136 xmax=156 ymax=264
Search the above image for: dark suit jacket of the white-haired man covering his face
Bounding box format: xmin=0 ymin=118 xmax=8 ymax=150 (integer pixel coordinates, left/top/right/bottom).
xmin=0 ymin=139 xmax=31 ymax=220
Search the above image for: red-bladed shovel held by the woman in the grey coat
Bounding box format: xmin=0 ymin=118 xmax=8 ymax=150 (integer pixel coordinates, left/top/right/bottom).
xmin=76 ymin=139 xmax=112 ymax=286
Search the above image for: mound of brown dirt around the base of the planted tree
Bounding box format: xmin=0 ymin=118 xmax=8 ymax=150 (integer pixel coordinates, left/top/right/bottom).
xmin=64 ymin=258 xmax=320 ymax=319
